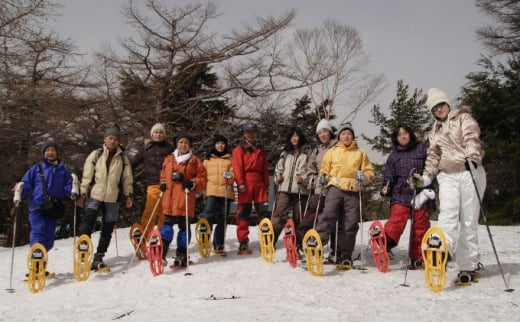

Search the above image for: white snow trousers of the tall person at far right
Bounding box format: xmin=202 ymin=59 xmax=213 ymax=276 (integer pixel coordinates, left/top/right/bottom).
xmin=437 ymin=166 xmax=486 ymax=271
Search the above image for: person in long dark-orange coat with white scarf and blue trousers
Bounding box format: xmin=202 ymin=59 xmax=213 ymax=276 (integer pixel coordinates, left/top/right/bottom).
xmin=160 ymin=133 xmax=207 ymax=268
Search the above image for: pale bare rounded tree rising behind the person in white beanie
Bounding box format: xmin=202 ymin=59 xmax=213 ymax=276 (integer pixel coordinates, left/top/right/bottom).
xmin=289 ymin=20 xmax=384 ymax=122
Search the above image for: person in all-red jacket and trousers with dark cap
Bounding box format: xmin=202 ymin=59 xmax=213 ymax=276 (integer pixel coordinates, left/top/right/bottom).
xmin=232 ymin=122 xmax=269 ymax=255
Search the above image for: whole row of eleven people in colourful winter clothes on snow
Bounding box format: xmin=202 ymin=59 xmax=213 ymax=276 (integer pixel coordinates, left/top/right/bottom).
xmin=13 ymin=88 xmax=485 ymax=282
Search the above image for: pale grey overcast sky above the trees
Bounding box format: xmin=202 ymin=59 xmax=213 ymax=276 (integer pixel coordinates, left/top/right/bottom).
xmin=53 ymin=0 xmax=492 ymax=162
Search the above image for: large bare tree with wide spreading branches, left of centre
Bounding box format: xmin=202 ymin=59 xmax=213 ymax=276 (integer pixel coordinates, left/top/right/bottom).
xmin=95 ymin=0 xmax=329 ymax=136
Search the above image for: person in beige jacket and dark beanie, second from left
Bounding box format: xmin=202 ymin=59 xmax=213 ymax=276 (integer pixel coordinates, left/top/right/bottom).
xmin=77 ymin=125 xmax=133 ymax=270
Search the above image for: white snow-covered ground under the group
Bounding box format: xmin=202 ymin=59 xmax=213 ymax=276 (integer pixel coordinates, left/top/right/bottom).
xmin=0 ymin=223 xmax=520 ymax=321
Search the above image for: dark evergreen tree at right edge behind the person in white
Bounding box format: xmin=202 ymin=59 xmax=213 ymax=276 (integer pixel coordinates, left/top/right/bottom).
xmin=462 ymin=58 xmax=520 ymax=224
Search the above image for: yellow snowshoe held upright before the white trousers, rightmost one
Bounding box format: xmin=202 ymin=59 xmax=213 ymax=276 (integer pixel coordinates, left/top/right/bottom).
xmin=421 ymin=227 xmax=448 ymax=293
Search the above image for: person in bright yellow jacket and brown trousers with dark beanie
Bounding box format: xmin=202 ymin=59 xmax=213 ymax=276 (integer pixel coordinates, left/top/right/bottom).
xmin=316 ymin=124 xmax=374 ymax=268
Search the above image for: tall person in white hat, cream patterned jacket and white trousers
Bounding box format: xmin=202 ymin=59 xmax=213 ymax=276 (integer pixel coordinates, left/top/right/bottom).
xmin=410 ymin=88 xmax=486 ymax=278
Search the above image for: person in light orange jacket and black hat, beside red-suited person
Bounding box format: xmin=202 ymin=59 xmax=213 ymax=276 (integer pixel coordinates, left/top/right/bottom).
xmin=201 ymin=134 xmax=235 ymax=254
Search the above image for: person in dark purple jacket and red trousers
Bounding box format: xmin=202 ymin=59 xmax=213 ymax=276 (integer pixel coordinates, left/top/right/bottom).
xmin=381 ymin=125 xmax=435 ymax=269
